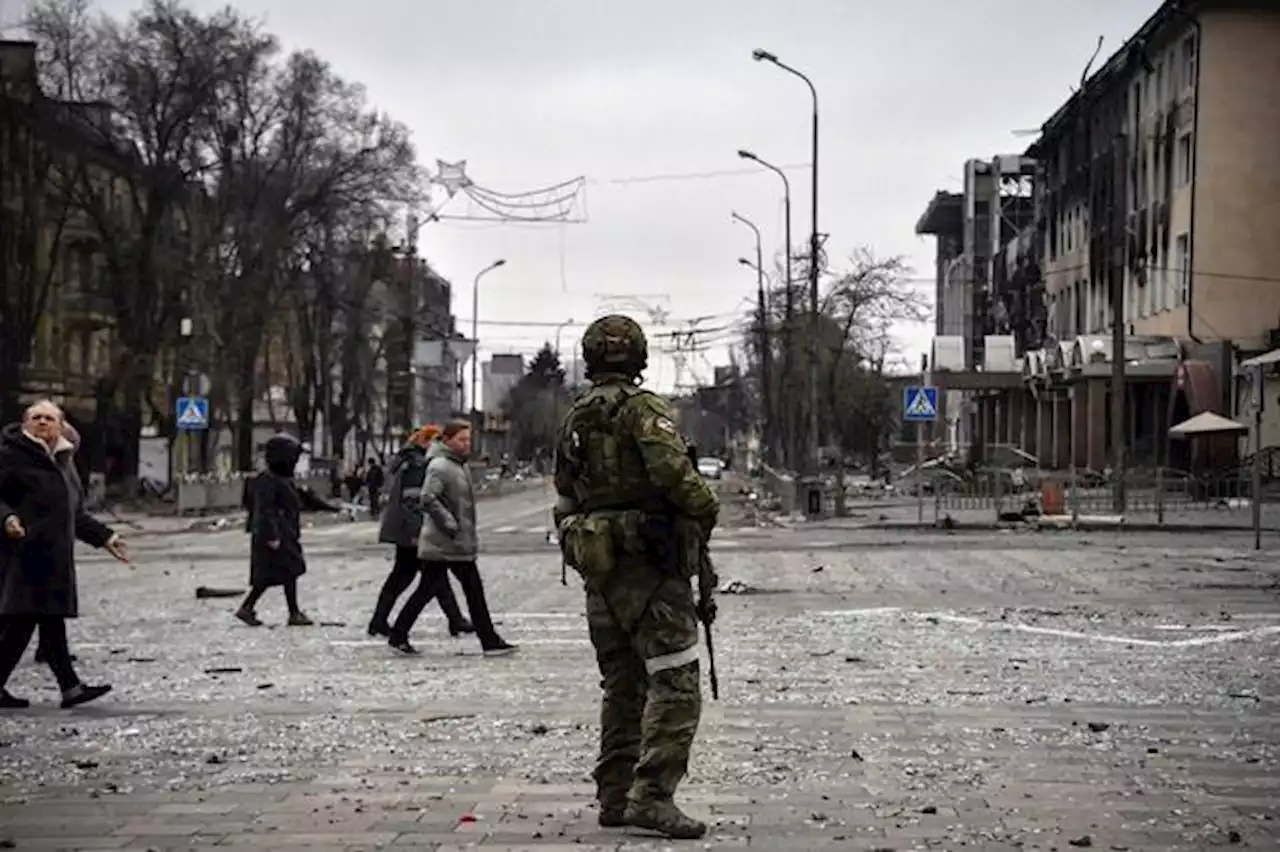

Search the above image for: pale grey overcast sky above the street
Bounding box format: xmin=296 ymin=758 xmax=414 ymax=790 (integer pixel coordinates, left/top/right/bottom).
xmin=4 ymin=0 xmax=1158 ymax=399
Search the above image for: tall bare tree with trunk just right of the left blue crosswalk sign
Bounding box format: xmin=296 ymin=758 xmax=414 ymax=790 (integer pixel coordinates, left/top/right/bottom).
xmin=186 ymin=50 xmax=419 ymax=468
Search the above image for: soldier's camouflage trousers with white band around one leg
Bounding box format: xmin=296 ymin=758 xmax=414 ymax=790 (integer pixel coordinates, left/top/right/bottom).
xmin=586 ymin=565 xmax=703 ymax=807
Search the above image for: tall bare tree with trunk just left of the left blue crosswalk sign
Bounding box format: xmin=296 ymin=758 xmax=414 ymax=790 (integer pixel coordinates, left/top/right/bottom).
xmin=29 ymin=0 xmax=263 ymax=473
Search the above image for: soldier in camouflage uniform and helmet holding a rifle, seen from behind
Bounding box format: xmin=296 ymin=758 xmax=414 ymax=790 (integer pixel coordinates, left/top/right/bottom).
xmin=556 ymin=316 xmax=719 ymax=839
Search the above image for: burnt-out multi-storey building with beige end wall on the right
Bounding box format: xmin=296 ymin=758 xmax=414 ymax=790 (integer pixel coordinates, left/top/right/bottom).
xmin=918 ymin=0 xmax=1280 ymax=469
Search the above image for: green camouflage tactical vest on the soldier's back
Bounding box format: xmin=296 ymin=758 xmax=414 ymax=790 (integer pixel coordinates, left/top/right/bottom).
xmin=561 ymin=384 xmax=666 ymax=513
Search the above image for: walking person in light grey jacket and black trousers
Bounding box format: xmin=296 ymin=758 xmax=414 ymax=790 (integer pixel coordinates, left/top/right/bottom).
xmin=388 ymin=421 xmax=516 ymax=656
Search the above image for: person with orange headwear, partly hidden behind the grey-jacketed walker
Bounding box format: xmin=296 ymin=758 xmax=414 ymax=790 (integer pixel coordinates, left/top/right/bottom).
xmin=369 ymin=426 xmax=475 ymax=637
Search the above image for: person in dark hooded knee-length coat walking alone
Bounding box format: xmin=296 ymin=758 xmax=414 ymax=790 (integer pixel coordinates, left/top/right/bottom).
xmin=236 ymin=434 xmax=340 ymax=627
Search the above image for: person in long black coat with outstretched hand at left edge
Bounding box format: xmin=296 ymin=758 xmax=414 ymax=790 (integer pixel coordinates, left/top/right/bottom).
xmin=0 ymin=400 xmax=129 ymax=709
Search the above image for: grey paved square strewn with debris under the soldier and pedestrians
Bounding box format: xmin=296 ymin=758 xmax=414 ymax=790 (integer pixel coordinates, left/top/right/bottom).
xmin=0 ymin=488 xmax=1280 ymax=852
